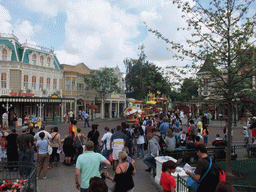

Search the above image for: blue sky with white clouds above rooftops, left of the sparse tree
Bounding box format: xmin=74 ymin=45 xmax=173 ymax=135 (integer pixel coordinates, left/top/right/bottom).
xmin=0 ymin=0 xmax=256 ymax=72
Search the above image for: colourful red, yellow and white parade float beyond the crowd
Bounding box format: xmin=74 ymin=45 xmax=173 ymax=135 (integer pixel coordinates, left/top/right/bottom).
xmin=124 ymin=92 xmax=167 ymax=121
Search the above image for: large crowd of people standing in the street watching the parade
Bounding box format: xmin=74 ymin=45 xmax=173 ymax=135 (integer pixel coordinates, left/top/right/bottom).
xmin=0 ymin=108 xmax=250 ymax=192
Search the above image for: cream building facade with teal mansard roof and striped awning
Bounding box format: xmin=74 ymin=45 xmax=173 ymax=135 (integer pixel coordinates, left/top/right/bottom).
xmin=0 ymin=33 xmax=74 ymax=126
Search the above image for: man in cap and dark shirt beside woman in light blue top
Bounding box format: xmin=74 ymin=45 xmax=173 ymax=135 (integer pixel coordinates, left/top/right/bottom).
xmin=17 ymin=126 xmax=34 ymax=177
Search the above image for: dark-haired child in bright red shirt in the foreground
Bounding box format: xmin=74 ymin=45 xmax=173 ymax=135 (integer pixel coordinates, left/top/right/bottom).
xmin=160 ymin=160 xmax=177 ymax=192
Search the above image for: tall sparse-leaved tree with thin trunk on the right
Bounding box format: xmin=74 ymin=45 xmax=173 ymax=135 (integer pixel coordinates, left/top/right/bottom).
xmin=150 ymin=0 xmax=256 ymax=173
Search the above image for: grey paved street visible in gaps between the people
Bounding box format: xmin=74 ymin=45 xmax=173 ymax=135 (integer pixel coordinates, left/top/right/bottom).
xmin=23 ymin=119 xmax=247 ymax=192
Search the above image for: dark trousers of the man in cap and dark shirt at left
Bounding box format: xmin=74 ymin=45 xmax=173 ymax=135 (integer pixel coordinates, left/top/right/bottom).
xmin=19 ymin=150 xmax=32 ymax=177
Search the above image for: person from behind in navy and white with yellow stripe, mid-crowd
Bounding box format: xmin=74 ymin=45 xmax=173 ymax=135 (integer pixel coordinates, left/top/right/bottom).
xmin=110 ymin=125 xmax=126 ymax=169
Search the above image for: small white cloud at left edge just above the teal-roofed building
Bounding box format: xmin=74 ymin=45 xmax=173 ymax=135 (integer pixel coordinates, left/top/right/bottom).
xmin=0 ymin=5 xmax=12 ymax=33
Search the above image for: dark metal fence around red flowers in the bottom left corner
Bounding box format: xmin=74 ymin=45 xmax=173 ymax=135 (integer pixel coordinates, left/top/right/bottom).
xmin=0 ymin=162 xmax=37 ymax=192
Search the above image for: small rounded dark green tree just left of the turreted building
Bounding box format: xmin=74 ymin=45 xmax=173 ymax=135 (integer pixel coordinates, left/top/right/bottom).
xmin=181 ymin=78 xmax=199 ymax=101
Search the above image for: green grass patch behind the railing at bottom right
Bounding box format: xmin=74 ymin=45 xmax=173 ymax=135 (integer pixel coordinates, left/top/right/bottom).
xmin=216 ymin=158 xmax=256 ymax=186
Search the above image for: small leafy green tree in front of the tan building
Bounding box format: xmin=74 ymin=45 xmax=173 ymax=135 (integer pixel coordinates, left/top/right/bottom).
xmin=85 ymin=67 xmax=120 ymax=118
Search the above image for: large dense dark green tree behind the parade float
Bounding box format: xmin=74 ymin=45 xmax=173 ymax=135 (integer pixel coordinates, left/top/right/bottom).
xmin=124 ymin=46 xmax=170 ymax=100
